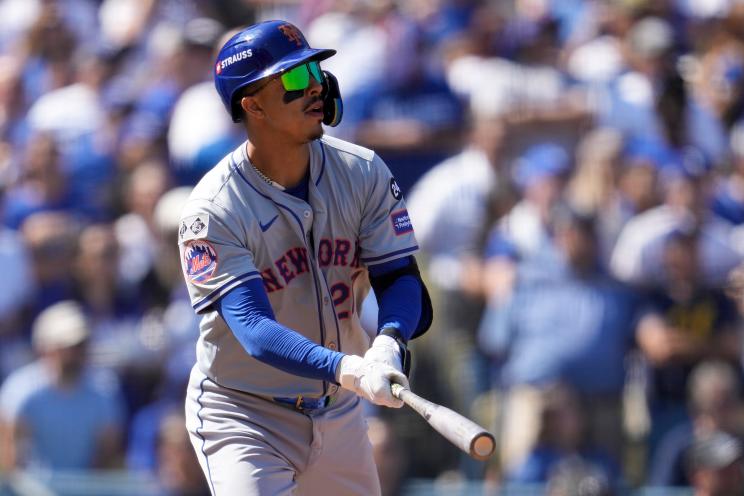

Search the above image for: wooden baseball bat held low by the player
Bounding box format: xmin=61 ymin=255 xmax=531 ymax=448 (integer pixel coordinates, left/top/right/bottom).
xmin=391 ymin=384 xmax=496 ymax=460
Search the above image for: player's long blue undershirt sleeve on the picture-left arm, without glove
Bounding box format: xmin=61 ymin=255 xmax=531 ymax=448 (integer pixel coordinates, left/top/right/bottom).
xmin=215 ymin=279 xmax=344 ymax=383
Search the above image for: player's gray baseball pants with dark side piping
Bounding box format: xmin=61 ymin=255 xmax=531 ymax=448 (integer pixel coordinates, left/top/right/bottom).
xmin=186 ymin=366 xmax=380 ymax=496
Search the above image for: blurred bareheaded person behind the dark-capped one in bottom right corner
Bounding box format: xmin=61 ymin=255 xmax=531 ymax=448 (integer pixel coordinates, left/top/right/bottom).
xmin=648 ymin=362 xmax=744 ymax=486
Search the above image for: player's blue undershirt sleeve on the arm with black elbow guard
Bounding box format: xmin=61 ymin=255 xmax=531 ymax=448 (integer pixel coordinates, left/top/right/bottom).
xmin=369 ymin=257 xmax=422 ymax=340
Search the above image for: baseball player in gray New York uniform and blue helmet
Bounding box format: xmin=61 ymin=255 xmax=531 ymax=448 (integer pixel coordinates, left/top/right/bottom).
xmin=179 ymin=21 xmax=432 ymax=496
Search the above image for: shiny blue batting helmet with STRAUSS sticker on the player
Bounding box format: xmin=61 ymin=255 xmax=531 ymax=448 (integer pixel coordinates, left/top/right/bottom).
xmin=214 ymin=21 xmax=336 ymax=122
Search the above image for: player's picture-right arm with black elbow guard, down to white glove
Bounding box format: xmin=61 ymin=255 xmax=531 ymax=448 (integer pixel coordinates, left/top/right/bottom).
xmin=364 ymin=255 xmax=433 ymax=375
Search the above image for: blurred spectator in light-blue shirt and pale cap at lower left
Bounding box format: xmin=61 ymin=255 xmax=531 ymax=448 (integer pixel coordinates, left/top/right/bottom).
xmin=0 ymin=301 xmax=124 ymax=470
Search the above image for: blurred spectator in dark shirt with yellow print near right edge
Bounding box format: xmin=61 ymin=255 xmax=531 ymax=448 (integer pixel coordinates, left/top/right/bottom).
xmin=636 ymin=232 xmax=741 ymax=460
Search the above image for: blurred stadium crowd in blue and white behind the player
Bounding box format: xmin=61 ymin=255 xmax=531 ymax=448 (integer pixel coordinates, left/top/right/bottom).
xmin=0 ymin=0 xmax=744 ymax=496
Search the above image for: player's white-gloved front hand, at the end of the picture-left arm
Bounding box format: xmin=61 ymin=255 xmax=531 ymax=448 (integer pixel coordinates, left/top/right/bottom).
xmin=336 ymin=355 xmax=409 ymax=408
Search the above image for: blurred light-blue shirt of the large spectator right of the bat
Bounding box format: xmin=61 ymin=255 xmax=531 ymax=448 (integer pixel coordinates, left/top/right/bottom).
xmin=480 ymin=271 xmax=634 ymax=393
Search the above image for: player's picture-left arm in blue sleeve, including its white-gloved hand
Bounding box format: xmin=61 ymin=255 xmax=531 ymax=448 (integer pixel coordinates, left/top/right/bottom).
xmin=215 ymin=279 xmax=408 ymax=408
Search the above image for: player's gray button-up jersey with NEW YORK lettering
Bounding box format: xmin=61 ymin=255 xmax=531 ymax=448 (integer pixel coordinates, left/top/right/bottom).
xmin=179 ymin=137 xmax=418 ymax=396
